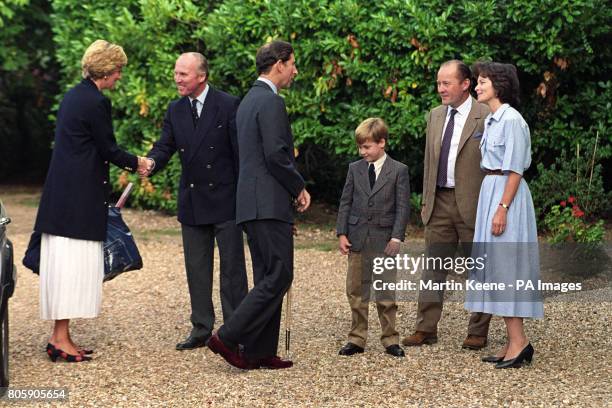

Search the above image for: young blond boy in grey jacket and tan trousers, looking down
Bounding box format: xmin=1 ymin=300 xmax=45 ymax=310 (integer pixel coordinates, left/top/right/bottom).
xmin=336 ymin=118 xmax=410 ymax=357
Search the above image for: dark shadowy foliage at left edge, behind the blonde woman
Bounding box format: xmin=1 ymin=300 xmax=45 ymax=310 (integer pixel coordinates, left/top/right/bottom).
xmin=0 ymin=0 xmax=57 ymax=183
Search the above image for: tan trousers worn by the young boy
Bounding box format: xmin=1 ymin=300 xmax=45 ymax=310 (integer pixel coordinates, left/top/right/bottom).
xmin=346 ymin=252 xmax=399 ymax=348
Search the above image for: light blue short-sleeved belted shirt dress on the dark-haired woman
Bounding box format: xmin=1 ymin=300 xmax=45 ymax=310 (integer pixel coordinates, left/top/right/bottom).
xmin=465 ymin=104 xmax=544 ymax=318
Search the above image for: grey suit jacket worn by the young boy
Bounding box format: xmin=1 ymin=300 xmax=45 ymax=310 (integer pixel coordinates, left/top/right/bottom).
xmin=336 ymin=155 xmax=410 ymax=252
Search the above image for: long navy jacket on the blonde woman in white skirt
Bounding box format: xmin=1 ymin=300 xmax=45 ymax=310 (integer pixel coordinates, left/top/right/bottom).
xmin=34 ymin=79 xmax=138 ymax=241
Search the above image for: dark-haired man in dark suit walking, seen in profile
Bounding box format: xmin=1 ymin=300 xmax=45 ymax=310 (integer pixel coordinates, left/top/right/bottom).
xmin=208 ymin=41 xmax=310 ymax=369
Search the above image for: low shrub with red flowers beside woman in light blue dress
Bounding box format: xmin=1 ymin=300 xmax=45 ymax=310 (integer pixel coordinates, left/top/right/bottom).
xmin=544 ymin=196 xmax=605 ymax=244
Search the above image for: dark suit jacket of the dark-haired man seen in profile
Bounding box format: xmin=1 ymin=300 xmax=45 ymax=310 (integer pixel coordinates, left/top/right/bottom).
xmin=236 ymin=81 xmax=304 ymax=224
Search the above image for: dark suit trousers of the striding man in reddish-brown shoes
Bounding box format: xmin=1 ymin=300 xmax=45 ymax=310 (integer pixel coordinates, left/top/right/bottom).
xmin=219 ymin=220 xmax=293 ymax=359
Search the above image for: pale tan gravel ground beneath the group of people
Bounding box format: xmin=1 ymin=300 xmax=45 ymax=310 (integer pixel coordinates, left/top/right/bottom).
xmin=0 ymin=186 xmax=612 ymax=407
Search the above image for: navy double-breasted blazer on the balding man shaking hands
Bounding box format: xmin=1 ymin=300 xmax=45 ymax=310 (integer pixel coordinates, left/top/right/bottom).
xmin=147 ymin=87 xmax=240 ymax=225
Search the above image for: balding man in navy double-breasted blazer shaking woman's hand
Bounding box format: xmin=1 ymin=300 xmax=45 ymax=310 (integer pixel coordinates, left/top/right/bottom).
xmin=142 ymin=52 xmax=248 ymax=350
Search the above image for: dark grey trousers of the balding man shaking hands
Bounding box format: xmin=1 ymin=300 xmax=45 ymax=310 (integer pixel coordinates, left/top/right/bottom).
xmin=181 ymin=220 xmax=248 ymax=338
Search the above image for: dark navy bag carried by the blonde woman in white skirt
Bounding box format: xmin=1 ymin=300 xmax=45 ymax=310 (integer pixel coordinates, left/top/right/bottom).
xmin=22 ymin=183 xmax=142 ymax=282
